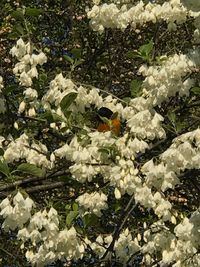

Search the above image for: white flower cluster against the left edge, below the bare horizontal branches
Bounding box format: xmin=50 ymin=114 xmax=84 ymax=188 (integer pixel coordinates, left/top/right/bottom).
xmin=0 ymin=192 xmax=34 ymax=231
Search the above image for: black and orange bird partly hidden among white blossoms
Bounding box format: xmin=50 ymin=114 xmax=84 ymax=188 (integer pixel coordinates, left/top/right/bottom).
xmin=97 ymin=107 xmax=121 ymax=136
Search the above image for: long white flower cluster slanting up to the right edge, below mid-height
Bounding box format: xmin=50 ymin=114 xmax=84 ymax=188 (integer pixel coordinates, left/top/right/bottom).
xmin=142 ymin=129 xmax=200 ymax=192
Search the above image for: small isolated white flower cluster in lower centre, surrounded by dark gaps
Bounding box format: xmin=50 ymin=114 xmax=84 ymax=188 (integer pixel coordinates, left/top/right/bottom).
xmin=76 ymin=192 xmax=108 ymax=217
